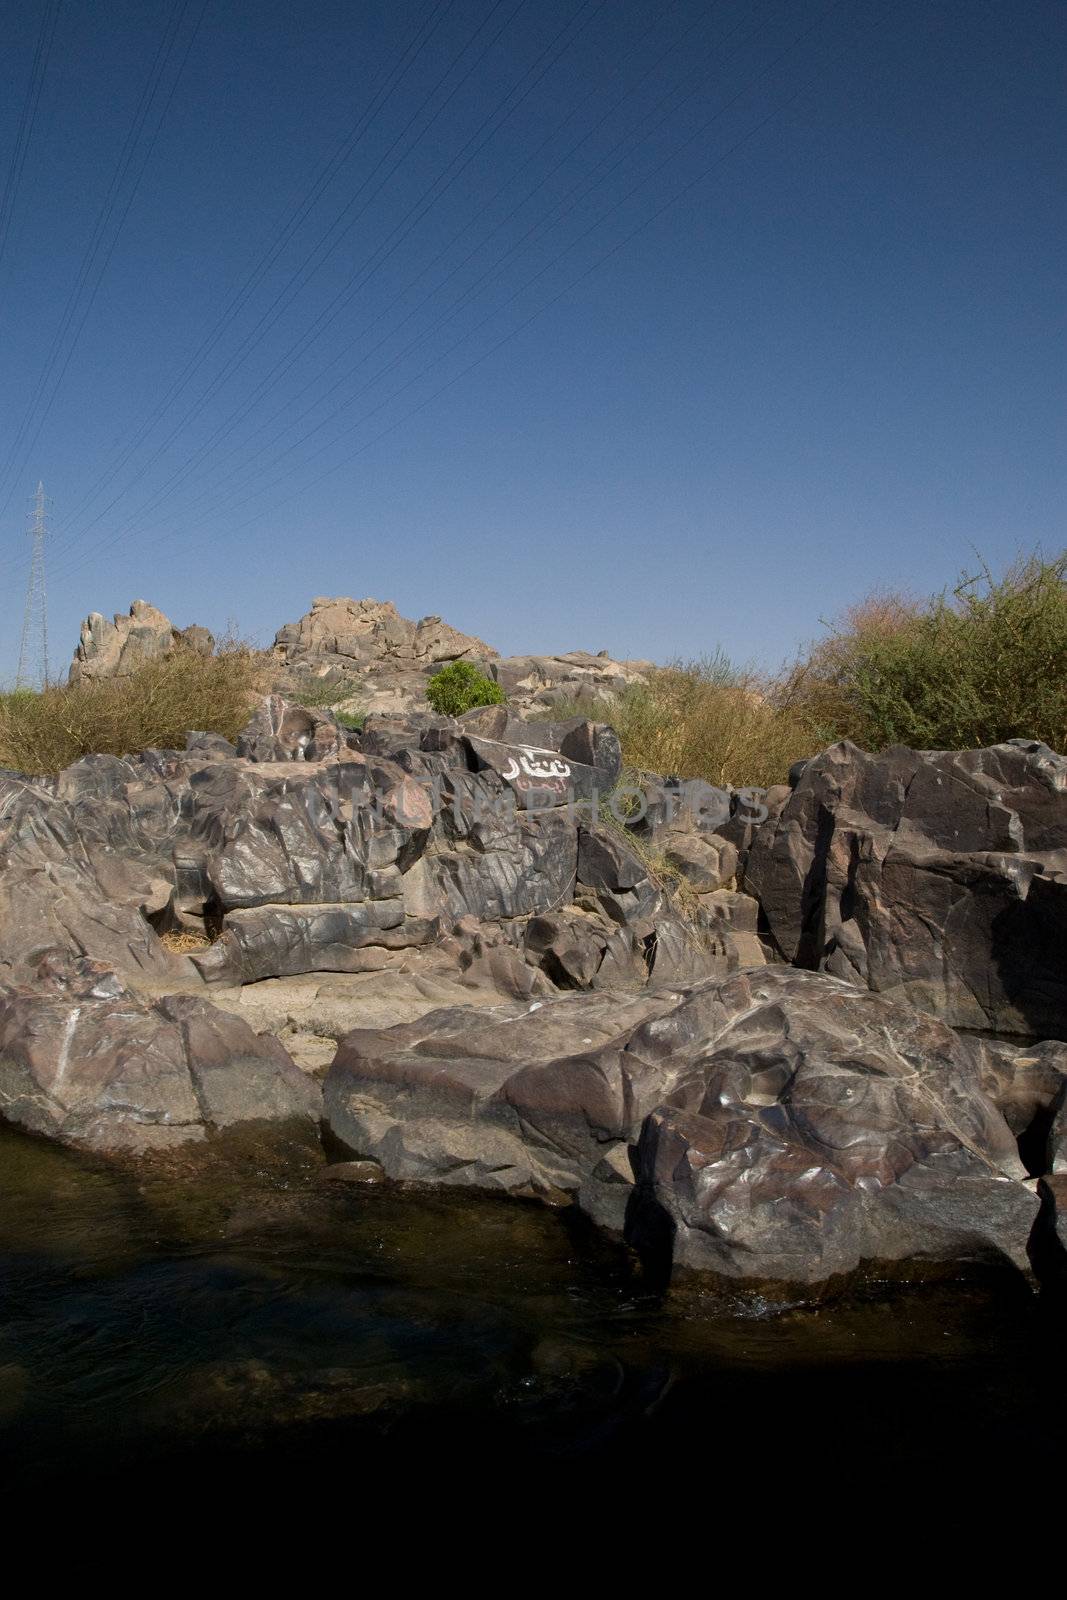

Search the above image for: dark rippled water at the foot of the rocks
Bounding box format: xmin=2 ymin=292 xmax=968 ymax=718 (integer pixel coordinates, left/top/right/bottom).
xmin=0 ymin=1131 xmax=1067 ymax=1506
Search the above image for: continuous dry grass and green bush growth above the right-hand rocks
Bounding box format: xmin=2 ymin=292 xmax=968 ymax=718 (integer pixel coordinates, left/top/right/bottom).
xmin=587 ymin=555 xmax=1067 ymax=787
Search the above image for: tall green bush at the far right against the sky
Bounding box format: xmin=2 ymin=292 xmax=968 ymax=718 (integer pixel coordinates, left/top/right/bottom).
xmin=782 ymin=554 xmax=1067 ymax=750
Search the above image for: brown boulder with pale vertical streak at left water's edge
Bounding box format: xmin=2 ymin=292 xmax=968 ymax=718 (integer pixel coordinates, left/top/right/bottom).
xmin=0 ymin=958 xmax=322 ymax=1154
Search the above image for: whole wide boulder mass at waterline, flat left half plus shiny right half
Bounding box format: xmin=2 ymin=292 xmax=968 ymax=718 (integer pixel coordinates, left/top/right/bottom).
xmin=325 ymin=968 xmax=1038 ymax=1283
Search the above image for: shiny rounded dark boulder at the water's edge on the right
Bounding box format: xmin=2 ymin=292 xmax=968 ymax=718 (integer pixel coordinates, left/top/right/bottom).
xmin=630 ymin=970 xmax=1037 ymax=1283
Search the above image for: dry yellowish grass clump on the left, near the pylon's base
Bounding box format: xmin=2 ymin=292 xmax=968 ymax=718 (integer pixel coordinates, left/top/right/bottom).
xmin=0 ymin=640 xmax=266 ymax=776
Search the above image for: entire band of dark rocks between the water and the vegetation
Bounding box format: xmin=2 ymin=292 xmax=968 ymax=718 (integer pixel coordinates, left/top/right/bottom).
xmin=0 ymin=603 xmax=1067 ymax=1291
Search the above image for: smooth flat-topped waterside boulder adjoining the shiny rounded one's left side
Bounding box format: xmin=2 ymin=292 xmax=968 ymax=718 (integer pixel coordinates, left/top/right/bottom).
xmin=323 ymin=990 xmax=678 ymax=1227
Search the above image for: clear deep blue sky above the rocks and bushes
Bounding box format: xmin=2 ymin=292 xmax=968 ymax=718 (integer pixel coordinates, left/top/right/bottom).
xmin=0 ymin=0 xmax=1067 ymax=680
